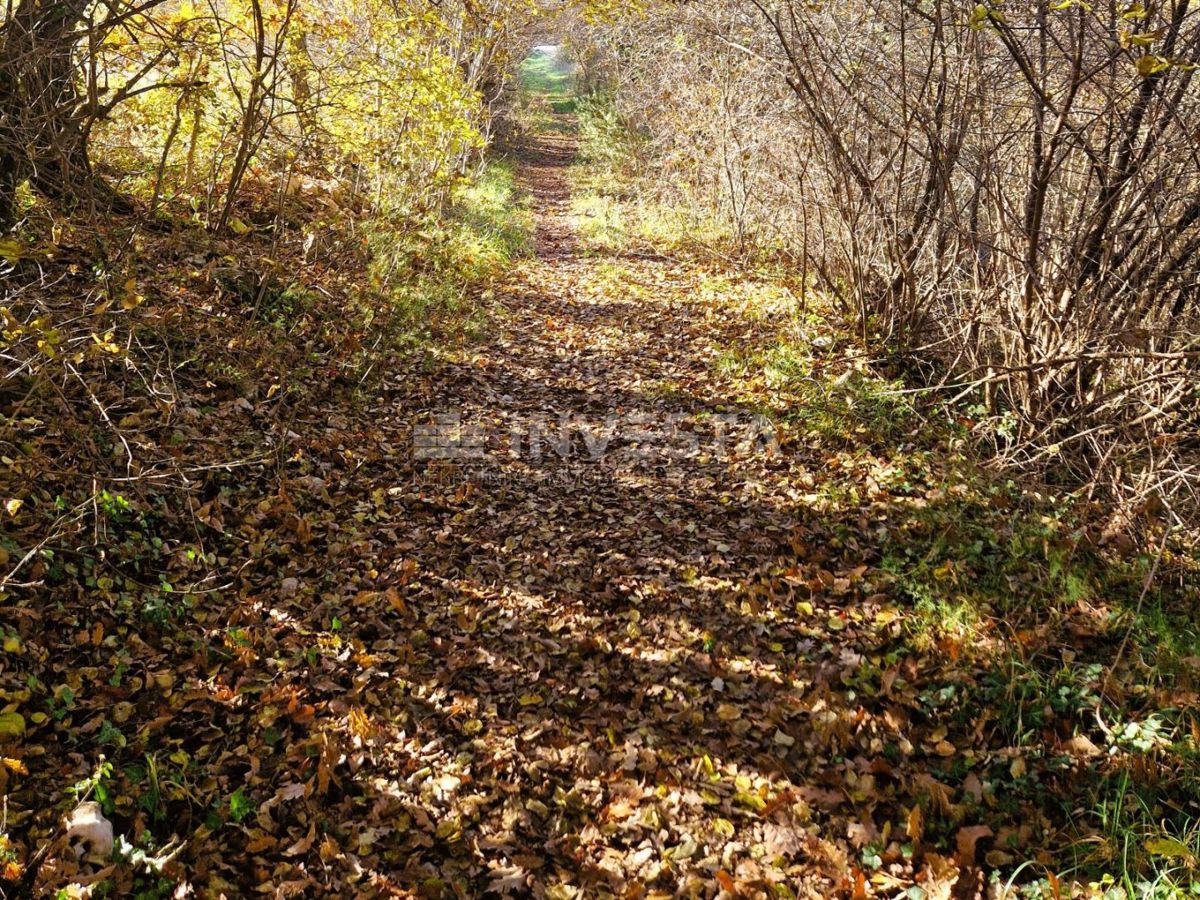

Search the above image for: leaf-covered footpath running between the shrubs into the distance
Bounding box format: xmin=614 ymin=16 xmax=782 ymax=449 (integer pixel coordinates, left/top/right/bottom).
xmin=180 ymin=125 xmax=984 ymax=896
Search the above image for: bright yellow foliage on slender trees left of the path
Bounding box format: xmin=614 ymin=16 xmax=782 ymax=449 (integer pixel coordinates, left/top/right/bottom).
xmin=85 ymin=0 xmax=532 ymax=222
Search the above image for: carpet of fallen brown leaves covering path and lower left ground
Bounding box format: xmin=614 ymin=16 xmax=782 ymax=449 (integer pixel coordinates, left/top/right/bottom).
xmin=14 ymin=107 xmax=1152 ymax=898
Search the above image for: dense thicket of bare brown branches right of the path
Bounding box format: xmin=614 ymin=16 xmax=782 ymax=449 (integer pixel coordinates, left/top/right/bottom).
xmin=581 ymin=0 xmax=1200 ymax=525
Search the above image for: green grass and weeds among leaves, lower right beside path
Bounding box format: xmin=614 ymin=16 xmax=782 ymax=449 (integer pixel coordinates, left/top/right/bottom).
xmin=880 ymin=480 xmax=1200 ymax=898
